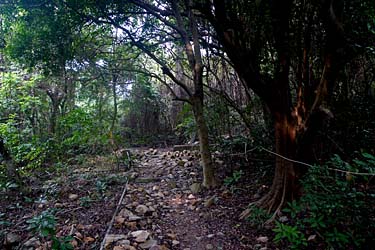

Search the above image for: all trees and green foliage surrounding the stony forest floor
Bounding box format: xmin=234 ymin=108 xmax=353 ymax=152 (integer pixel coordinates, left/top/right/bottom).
xmin=0 ymin=0 xmax=375 ymax=249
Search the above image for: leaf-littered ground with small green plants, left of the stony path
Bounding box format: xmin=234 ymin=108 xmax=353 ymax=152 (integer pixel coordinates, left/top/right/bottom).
xmin=0 ymin=156 xmax=131 ymax=249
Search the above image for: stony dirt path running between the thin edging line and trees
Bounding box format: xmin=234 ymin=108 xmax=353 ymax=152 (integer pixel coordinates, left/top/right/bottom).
xmin=104 ymin=149 xmax=272 ymax=250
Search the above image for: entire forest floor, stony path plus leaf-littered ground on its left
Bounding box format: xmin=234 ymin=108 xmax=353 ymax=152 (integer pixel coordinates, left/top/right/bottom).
xmin=0 ymin=149 xmax=275 ymax=250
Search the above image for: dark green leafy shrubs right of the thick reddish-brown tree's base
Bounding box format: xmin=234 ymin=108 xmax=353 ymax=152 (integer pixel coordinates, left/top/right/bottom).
xmin=274 ymin=153 xmax=375 ymax=249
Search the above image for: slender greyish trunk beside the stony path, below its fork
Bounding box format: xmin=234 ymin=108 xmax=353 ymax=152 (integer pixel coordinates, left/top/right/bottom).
xmin=192 ymin=98 xmax=217 ymax=188
